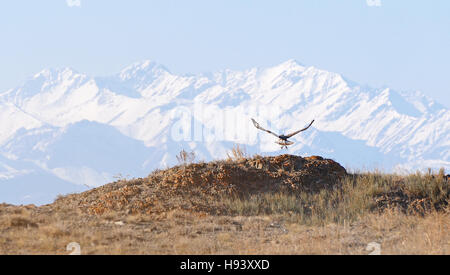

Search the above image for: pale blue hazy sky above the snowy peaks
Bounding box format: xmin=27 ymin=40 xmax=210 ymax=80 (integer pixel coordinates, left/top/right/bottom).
xmin=0 ymin=0 xmax=450 ymax=107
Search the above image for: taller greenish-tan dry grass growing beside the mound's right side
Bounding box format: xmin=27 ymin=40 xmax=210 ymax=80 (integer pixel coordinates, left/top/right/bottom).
xmin=222 ymin=173 xmax=450 ymax=225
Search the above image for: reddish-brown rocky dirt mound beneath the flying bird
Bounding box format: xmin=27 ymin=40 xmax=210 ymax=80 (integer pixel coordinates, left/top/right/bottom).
xmin=55 ymin=155 xmax=347 ymax=214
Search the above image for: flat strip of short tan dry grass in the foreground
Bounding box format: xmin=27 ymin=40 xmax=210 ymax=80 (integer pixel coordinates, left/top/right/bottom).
xmin=0 ymin=205 xmax=450 ymax=254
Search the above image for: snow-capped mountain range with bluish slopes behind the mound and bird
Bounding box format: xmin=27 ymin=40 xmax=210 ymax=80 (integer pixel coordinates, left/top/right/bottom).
xmin=0 ymin=60 xmax=450 ymax=207
